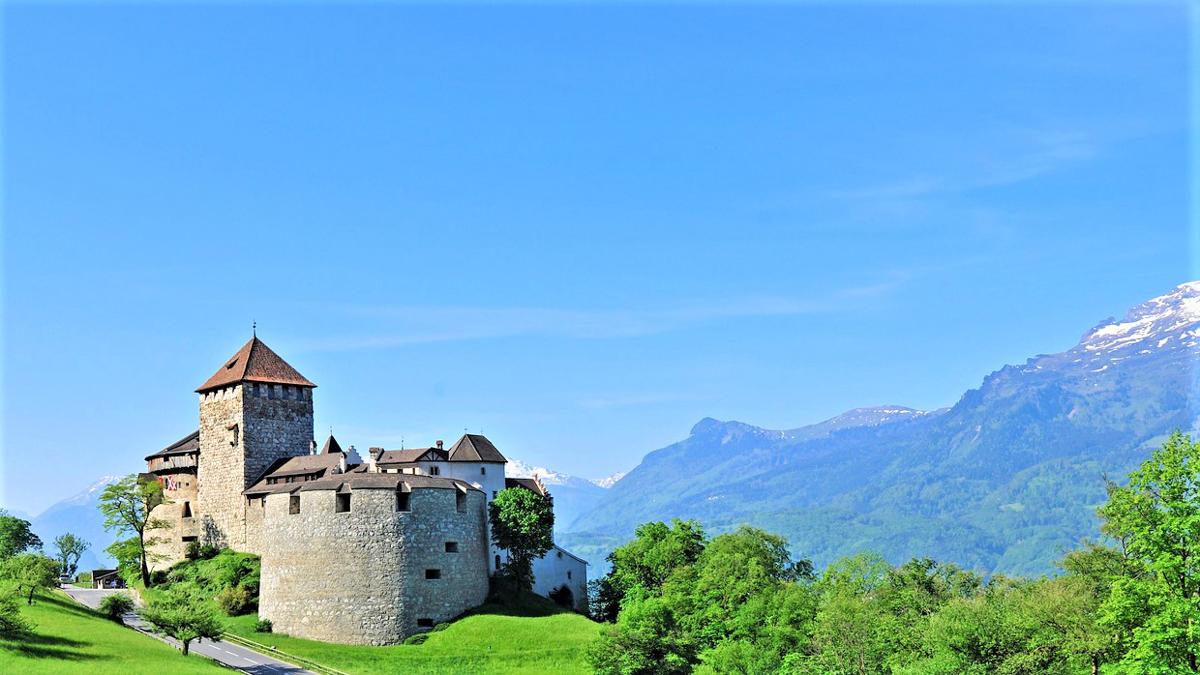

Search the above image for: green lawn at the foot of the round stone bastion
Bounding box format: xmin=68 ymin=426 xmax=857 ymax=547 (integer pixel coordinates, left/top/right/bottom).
xmin=229 ymin=590 xmax=600 ymax=675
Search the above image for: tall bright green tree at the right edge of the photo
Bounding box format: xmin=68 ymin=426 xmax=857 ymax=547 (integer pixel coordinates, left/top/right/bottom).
xmin=1099 ymin=432 xmax=1200 ymax=675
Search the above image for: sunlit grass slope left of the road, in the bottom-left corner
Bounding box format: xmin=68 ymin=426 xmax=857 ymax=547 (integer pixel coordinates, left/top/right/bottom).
xmin=0 ymin=591 xmax=229 ymax=675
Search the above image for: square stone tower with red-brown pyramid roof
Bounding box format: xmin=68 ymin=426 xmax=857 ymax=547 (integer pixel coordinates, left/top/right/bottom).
xmin=196 ymin=335 xmax=317 ymax=552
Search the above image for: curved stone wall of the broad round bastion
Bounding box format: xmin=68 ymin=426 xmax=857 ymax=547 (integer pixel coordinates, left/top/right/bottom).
xmin=259 ymin=488 xmax=488 ymax=645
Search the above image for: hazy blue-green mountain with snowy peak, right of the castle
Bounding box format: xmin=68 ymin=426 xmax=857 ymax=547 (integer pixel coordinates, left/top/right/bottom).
xmin=560 ymin=282 xmax=1200 ymax=573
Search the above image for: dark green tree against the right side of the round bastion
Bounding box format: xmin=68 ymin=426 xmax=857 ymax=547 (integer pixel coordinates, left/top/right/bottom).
xmin=488 ymin=488 xmax=554 ymax=591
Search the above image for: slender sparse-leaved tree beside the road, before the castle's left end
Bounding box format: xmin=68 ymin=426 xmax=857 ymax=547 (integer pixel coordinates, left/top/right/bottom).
xmin=100 ymin=473 xmax=168 ymax=587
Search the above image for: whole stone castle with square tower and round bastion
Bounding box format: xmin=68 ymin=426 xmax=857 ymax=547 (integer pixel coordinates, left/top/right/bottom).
xmin=145 ymin=335 xmax=587 ymax=645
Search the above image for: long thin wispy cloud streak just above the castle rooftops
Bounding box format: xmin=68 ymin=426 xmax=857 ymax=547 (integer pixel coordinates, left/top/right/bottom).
xmin=298 ymin=278 xmax=910 ymax=352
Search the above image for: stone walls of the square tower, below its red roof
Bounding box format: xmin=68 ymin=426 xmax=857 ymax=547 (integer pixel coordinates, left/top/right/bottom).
xmin=198 ymin=383 xmax=313 ymax=552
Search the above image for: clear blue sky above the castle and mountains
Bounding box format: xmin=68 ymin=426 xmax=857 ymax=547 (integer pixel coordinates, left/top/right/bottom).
xmin=0 ymin=4 xmax=1194 ymax=513
